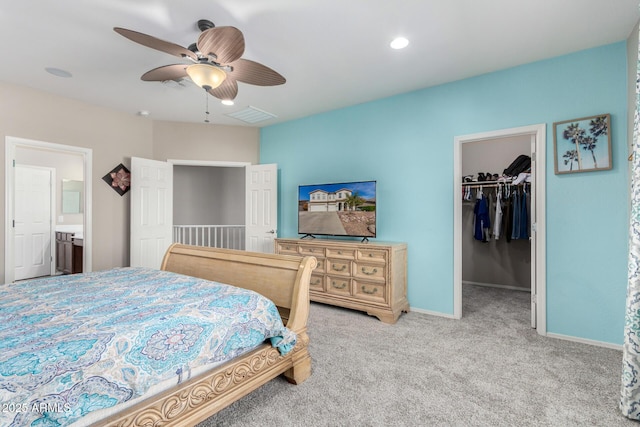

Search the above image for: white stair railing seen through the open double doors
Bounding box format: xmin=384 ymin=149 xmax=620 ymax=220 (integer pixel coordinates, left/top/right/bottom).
xmin=173 ymin=225 xmax=245 ymax=250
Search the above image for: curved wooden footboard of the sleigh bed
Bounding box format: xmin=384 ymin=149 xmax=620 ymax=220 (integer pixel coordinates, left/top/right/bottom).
xmin=161 ymin=243 xmax=317 ymax=329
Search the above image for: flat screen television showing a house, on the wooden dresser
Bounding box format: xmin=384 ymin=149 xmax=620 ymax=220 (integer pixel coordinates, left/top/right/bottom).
xmin=298 ymin=181 xmax=376 ymax=240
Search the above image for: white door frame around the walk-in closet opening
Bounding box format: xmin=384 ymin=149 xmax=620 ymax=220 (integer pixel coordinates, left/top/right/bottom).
xmin=453 ymin=123 xmax=547 ymax=335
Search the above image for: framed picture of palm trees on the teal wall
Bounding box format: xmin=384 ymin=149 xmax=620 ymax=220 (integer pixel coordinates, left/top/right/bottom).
xmin=553 ymin=114 xmax=613 ymax=174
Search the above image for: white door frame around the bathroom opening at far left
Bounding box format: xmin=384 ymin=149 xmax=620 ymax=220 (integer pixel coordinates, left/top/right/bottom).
xmin=4 ymin=136 xmax=93 ymax=283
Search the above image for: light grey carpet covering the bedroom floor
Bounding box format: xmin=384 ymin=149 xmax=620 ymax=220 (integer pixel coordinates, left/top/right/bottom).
xmin=199 ymin=285 xmax=639 ymax=427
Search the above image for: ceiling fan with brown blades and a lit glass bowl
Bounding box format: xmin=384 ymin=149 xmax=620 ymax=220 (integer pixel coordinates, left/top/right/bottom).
xmin=113 ymin=19 xmax=286 ymax=100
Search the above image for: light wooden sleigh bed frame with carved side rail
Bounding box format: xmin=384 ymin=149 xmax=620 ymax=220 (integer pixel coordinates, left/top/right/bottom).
xmin=95 ymin=244 xmax=316 ymax=427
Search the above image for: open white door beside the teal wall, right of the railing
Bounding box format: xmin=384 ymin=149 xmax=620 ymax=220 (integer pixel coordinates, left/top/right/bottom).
xmin=245 ymin=164 xmax=278 ymax=253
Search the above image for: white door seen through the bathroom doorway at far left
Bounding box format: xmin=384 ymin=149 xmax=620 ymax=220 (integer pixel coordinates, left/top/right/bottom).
xmin=14 ymin=165 xmax=53 ymax=280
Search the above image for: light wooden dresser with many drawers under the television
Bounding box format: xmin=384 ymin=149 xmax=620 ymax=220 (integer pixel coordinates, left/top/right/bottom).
xmin=275 ymin=239 xmax=409 ymax=323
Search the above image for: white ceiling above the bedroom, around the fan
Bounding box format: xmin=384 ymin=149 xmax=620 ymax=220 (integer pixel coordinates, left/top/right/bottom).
xmin=0 ymin=0 xmax=640 ymax=126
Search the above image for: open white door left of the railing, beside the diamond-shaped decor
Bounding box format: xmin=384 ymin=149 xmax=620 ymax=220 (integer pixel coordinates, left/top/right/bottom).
xmin=130 ymin=157 xmax=173 ymax=268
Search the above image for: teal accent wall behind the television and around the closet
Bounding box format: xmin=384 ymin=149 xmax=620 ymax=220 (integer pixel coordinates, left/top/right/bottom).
xmin=260 ymin=42 xmax=628 ymax=344
